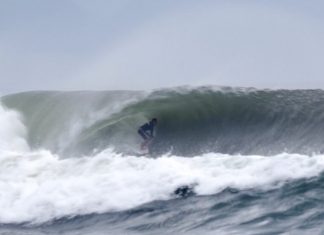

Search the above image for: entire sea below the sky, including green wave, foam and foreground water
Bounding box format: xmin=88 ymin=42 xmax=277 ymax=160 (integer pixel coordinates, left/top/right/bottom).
xmin=0 ymin=86 xmax=324 ymax=235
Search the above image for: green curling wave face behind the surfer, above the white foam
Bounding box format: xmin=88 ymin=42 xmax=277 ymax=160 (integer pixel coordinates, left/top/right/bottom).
xmin=3 ymin=88 xmax=324 ymax=156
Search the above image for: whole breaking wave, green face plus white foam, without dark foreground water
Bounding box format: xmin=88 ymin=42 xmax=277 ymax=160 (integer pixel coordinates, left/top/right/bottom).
xmin=0 ymin=86 xmax=324 ymax=223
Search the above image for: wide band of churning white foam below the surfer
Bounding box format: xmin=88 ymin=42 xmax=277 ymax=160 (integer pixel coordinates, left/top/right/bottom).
xmin=0 ymin=150 xmax=324 ymax=223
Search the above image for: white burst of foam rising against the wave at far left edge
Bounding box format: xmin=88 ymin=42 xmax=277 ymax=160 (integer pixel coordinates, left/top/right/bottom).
xmin=0 ymin=103 xmax=29 ymax=151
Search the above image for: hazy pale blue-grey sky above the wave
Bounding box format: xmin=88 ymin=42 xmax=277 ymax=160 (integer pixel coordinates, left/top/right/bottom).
xmin=0 ymin=0 xmax=324 ymax=94
